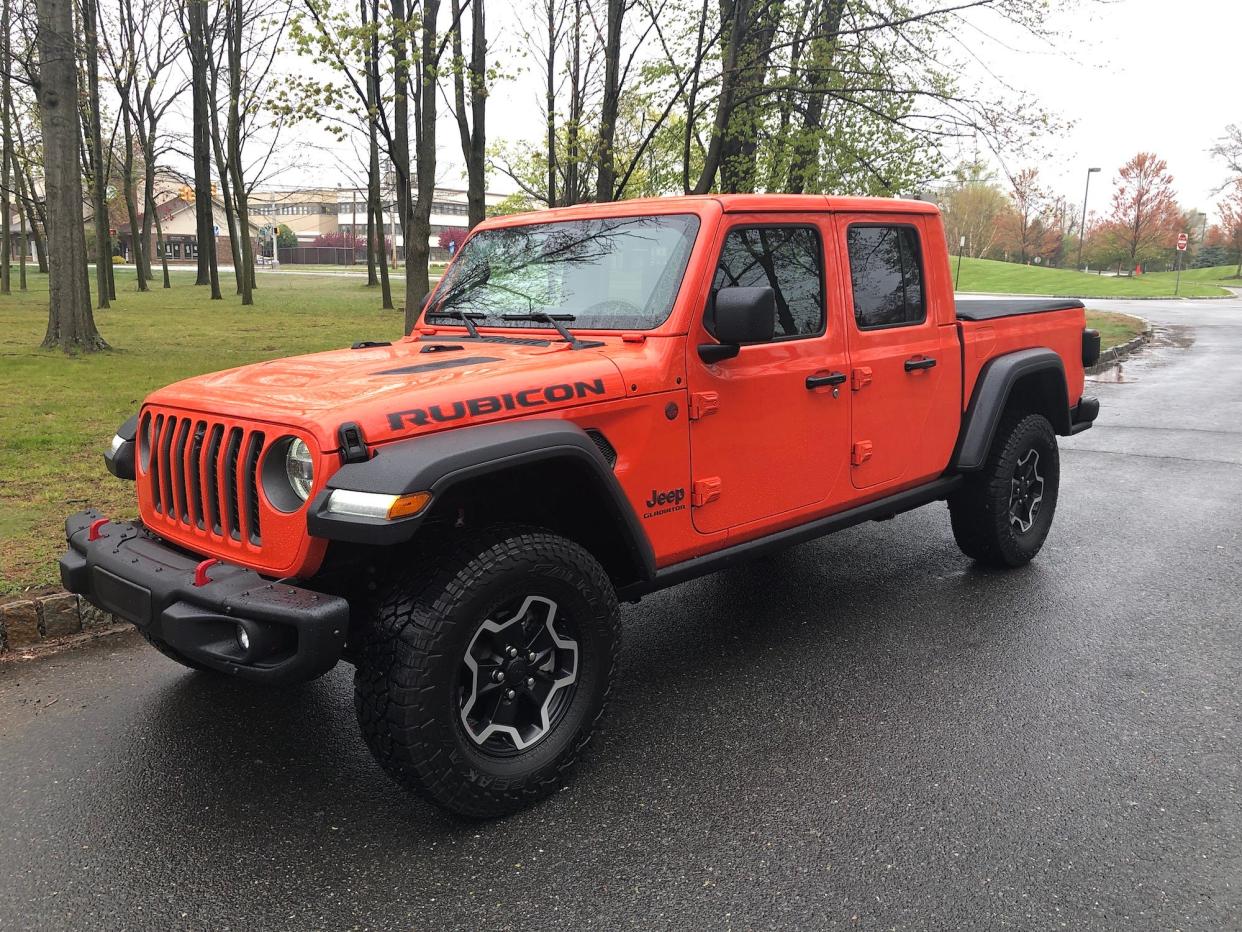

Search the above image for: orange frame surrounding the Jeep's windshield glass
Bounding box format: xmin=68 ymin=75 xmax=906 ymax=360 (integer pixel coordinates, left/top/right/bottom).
xmin=415 ymin=206 xmax=722 ymax=337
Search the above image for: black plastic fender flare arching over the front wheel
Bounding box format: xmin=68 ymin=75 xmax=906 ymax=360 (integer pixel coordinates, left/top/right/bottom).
xmin=307 ymin=419 xmax=656 ymax=579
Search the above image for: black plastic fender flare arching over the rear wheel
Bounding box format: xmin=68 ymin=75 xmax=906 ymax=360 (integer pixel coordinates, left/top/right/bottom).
xmin=950 ymin=348 xmax=1071 ymax=472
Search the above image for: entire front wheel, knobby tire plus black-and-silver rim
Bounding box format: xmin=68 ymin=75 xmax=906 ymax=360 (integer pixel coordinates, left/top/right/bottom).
xmin=354 ymin=528 xmax=620 ymax=818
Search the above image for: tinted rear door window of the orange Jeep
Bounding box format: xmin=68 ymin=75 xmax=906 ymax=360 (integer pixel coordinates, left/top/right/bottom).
xmin=846 ymin=226 xmax=927 ymax=331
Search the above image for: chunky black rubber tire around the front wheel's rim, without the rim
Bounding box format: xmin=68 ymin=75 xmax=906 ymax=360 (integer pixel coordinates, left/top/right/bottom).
xmin=354 ymin=526 xmax=621 ymax=819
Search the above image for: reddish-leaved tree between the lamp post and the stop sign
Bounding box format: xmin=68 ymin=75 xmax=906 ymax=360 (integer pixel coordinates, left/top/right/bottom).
xmin=1104 ymin=152 xmax=1181 ymax=268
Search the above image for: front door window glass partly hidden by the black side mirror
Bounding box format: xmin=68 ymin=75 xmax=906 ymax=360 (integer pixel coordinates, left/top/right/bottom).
xmin=707 ymin=226 xmax=823 ymax=338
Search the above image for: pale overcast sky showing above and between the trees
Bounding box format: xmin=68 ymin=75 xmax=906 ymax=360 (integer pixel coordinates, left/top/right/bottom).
xmin=269 ymin=0 xmax=1242 ymax=212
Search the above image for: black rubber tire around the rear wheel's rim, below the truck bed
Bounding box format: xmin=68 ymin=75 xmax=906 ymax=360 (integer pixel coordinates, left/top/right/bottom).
xmin=949 ymin=413 xmax=1061 ymax=568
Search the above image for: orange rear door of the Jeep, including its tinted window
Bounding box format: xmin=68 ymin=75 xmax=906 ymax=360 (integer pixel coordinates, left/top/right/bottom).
xmin=837 ymin=214 xmax=960 ymax=492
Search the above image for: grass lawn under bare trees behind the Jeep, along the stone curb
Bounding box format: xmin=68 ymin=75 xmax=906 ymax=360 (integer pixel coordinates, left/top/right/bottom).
xmin=0 ymin=271 xmax=1143 ymax=595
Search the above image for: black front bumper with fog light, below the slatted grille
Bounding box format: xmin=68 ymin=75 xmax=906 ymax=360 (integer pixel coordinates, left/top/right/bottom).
xmin=61 ymin=511 xmax=349 ymax=685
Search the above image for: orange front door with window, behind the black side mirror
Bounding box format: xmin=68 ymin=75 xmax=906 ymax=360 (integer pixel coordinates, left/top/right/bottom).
xmin=687 ymin=214 xmax=850 ymax=533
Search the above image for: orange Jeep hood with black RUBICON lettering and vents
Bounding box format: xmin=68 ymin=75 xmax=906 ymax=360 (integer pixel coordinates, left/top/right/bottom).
xmin=147 ymin=336 xmax=626 ymax=450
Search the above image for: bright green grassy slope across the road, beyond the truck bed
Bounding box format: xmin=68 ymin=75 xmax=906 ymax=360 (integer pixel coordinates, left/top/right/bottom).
xmin=950 ymin=257 xmax=1232 ymax=298
